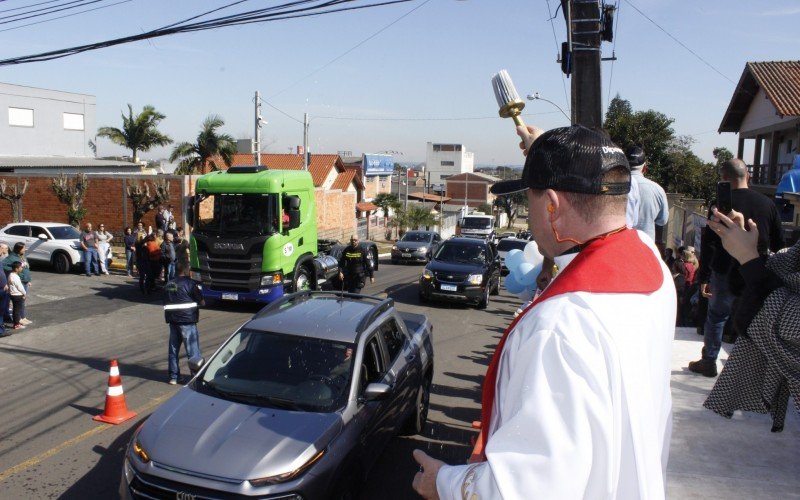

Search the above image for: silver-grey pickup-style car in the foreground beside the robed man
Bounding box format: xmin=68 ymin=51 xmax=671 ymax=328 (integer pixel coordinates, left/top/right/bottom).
xmin=120 ymin=292 xmax=433 ymax=499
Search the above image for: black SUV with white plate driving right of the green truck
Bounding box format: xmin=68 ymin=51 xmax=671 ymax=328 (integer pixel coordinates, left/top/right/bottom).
xmin=419 ymin=238 xmax=500 ymax=309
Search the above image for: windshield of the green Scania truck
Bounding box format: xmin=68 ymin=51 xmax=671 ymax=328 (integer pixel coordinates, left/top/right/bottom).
xmin=195 ymin=193 xmax=278 ymax=235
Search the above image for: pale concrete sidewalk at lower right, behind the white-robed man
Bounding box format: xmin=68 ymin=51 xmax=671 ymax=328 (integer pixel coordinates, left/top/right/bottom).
xmin=667 ymin=328 xmax=800 ymax=499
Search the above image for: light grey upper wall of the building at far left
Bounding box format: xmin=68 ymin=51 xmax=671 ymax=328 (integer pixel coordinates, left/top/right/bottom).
xmin=0 ymin=83 xmax=97 ymax=157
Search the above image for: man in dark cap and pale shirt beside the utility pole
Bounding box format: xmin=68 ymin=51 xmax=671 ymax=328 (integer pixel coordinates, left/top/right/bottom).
xmin=625 ymin=146 xmax=669 ymax=241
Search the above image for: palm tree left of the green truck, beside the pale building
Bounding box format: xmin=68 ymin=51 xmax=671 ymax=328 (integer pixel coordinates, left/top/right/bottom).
xmin=97 ymin=104 xmax=172 ymax=163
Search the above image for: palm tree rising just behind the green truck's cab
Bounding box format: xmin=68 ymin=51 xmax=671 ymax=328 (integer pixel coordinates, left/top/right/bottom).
xmin=169 ymin=115 xmax=236 ymax=175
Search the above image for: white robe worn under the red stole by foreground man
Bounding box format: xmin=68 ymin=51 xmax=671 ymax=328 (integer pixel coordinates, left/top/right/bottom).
xmin=436 ymin=232 xmax=676 ymax=500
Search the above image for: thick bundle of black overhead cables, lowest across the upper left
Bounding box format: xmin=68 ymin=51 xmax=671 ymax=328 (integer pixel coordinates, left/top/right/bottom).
xmin=0 ymin=0 xmax=414 ymax=66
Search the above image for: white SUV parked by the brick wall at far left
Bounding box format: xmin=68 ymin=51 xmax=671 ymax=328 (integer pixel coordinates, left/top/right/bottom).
xmin=0 ymin=222 xmax=83 ymax=273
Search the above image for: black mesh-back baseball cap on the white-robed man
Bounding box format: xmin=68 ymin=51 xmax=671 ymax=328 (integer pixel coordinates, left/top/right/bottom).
xmin=491 ymin=125 xmax=631 ymax=195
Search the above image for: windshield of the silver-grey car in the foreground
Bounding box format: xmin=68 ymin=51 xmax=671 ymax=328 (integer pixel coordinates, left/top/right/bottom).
xmin=195 ymin=328 xmax=355 ymax=412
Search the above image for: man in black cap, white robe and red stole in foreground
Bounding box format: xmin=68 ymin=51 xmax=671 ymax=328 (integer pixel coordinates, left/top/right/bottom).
xmin=413 ymin=126 xmax=676 ymax=499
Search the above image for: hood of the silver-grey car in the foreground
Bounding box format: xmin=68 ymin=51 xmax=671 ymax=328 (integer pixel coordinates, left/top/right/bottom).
xmin=138 ymin=387 xmax=342 ymax=481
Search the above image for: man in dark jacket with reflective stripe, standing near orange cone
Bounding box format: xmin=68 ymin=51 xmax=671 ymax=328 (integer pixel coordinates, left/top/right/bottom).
xmin=164 ymin=266 xmax=205 ymax=385
